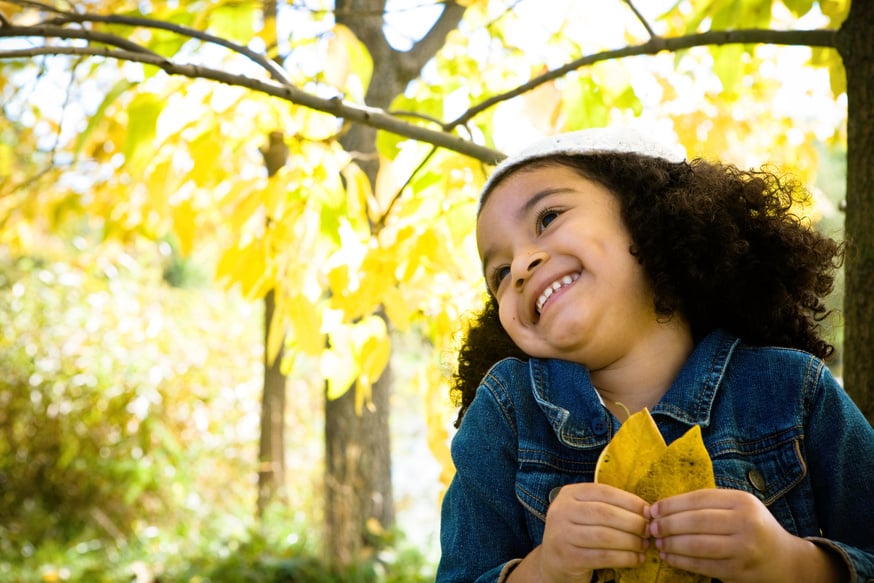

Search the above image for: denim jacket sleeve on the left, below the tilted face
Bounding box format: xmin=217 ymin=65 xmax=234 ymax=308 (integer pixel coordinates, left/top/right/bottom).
xmin=436 ymin=377 xmax=532 ymax=583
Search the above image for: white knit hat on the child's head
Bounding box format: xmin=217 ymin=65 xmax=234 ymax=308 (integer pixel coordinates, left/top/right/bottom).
xmin=481 ymin=127 xmax=686 ymax=198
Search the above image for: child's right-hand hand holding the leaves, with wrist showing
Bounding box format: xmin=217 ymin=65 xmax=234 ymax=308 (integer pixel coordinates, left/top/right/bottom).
xmin=647 ymin=489 xmax=848 ymax=583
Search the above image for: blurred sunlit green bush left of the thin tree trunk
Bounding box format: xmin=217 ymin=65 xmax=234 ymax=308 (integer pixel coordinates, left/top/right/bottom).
xmin=0 ymin=253 xmax=260 ymax=561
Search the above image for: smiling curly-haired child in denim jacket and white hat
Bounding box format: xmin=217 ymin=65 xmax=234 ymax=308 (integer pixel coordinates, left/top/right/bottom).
xmin=437 ymin=129 xmax=874 ymax=583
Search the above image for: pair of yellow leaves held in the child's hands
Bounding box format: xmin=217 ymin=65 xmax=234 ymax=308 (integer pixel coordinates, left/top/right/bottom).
xmin=595 ymin=409 xmax=716 ymax=583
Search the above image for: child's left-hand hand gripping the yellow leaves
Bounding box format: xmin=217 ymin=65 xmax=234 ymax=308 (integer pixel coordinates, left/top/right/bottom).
xmin=540 ymin=483 xmax=647 ymax=582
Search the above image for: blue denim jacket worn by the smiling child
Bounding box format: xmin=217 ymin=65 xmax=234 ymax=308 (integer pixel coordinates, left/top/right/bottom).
xmin=437 ymin=331 xmax=874 ymax=583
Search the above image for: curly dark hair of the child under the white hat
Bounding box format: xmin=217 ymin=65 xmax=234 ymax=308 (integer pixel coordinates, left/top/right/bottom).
xmin=452 ymin=153 xmax=844 ymax=425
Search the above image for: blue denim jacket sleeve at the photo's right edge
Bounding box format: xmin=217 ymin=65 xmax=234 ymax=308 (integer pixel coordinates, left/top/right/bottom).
xmin=806 ymin=366 xmax=874 ymax=583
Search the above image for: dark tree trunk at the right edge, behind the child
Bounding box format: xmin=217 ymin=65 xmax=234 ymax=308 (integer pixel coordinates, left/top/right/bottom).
xmin=838 ymin=0 xmax=874 ymax=423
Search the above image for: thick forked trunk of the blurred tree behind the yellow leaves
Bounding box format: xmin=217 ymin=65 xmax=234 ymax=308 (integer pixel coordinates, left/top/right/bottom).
xmin=325 ymin=0 xmax=464 ymax=567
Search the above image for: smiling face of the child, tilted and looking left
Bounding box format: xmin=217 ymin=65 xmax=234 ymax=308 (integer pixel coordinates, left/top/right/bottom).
xmin=477 ymin=165 xmax=659 ymax=369
